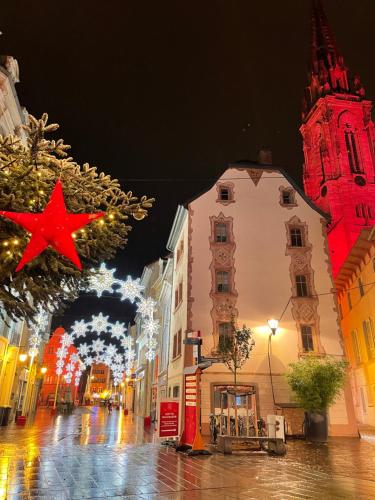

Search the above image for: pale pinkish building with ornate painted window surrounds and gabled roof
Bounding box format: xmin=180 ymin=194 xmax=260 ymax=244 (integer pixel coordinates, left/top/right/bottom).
xmin=167 ymin=157 xmax=356 ymax=435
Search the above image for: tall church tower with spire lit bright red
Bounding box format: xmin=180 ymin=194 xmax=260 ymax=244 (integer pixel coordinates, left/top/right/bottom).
xmin=300 ymin=0 xmax=375 ymax=276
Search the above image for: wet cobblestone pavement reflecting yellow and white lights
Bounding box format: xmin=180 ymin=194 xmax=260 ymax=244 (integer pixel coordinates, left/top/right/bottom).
xmin=0 ymin=408 xmax=375 ymax=500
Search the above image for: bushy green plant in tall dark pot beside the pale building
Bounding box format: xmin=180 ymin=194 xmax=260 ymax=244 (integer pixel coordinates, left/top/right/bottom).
xmin=286 ymin=356 xmax=348 ymax=441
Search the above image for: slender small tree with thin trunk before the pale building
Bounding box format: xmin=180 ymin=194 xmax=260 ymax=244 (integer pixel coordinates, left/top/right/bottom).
xmin=216 ymin=317 xmax=255 ymax=435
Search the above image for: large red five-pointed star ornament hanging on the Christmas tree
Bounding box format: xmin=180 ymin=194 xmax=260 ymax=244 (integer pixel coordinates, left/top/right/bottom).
xmin=0 ymin=179 xmax=104 ymax=271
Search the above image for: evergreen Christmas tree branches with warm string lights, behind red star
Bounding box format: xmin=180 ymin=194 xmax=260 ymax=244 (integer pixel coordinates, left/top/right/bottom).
xmin=0 ymin=114 xmax=154 ymax=320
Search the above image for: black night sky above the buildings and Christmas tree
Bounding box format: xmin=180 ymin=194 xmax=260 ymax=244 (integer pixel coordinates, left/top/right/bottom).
xmin=0 ymin=0 xmax=375 ymax=332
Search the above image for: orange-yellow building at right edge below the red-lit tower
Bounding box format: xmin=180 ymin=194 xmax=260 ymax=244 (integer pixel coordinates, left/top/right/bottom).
xmin=336 ymin=226 xmax=375 ymax=426
